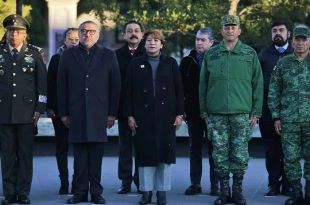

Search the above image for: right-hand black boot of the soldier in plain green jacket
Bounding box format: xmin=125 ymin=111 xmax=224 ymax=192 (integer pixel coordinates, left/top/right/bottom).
xmin=232 ymin=174 xmax=246 ymax=205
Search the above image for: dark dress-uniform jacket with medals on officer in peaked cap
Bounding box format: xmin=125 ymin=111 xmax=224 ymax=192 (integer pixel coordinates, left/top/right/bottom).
xmin=0 ymin=43 xmax=46 ymax=124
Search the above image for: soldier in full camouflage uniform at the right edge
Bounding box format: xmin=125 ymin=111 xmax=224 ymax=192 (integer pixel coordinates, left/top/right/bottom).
xmin=268 ymin=25 xmax=310 ymax=205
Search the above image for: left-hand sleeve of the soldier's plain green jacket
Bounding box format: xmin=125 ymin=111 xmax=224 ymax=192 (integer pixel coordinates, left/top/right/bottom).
xmin=199 ymin=55 xmax=209 ymax=119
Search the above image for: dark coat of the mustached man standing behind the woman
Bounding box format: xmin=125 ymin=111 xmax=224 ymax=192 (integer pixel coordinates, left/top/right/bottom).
xmin=115 ymin=43 xmax=145 ymax=120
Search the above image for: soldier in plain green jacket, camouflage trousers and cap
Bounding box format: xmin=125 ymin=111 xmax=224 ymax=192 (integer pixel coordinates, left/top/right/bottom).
xmin=199 ymin=15 xmax=263 ymax=205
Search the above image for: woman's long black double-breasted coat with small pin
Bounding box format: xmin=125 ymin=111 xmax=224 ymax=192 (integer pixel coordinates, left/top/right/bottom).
xmin=125 ymin=55 xmax=184 ymax=166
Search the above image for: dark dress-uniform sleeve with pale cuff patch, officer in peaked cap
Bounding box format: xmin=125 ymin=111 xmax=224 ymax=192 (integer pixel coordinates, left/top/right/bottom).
xmin=35 ymin=52 xmax=47 ymax=113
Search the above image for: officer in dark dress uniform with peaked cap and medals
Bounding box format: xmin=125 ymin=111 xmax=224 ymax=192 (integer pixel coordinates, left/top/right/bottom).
xmin=0 ymin=15 xmax=46 ymax=205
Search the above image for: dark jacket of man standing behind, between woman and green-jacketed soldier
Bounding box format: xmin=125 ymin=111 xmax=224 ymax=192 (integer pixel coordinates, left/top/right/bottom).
xmin=180 ymin=50 xmax=201 ymax=122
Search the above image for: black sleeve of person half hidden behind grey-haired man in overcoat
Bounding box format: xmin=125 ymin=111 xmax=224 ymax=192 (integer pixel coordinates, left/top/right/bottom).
xmin=46 ymin=55 xmax=59 ymax=111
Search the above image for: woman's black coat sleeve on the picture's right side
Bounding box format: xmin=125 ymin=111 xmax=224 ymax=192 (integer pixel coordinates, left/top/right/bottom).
xmin=172 ymin=59 xmax=184 ymax=115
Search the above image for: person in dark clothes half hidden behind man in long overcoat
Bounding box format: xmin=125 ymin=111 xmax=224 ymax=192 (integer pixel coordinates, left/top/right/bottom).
xmin=46 ymin=28 xmax=79 ymax=194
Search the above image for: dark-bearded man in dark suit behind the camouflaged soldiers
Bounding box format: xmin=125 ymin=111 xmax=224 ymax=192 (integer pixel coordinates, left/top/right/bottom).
xmin=258 ymin=21 xmax=293 ymax=196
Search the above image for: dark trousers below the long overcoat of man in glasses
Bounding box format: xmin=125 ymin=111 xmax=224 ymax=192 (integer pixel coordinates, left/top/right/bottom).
xmin=73 ymin=142 xmax=104 ymax=195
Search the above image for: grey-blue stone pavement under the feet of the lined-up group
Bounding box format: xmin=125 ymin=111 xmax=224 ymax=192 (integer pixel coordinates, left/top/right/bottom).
xmin=0 ymin=156 xmax=286 ymax=205
